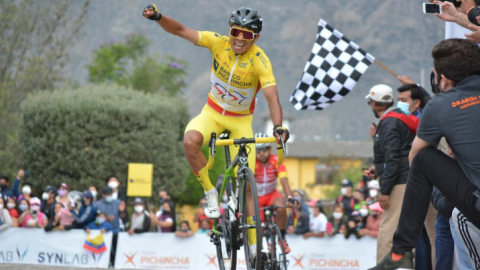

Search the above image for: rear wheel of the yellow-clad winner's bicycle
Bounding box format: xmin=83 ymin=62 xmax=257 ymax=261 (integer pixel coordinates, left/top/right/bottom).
xmin=215 ymin=175 xmax=237 ymax=270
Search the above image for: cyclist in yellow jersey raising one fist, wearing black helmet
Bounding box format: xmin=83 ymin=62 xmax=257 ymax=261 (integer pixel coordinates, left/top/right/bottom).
xmin=143 ymin=5 xmax=288 ymax=258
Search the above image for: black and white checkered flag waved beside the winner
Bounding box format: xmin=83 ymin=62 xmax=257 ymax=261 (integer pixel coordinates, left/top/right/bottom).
xmin=290 ymin=19 xmax=375 ymax=110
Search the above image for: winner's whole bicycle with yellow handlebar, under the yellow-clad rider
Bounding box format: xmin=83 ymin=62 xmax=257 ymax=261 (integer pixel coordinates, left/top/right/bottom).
xmin=207 ymin=131 xmax=285 ymax=270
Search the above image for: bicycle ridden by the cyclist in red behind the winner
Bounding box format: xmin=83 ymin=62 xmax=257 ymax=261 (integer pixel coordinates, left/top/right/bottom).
xmin=260 ymin=205 xmax=295 ymax=270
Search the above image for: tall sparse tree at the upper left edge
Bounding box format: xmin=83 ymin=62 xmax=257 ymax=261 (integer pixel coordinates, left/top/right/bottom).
xmin=0 ymin=0 xmax=90 ymax=175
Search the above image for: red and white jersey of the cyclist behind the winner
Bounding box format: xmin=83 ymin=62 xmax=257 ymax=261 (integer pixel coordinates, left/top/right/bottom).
xmin=255 ymin=155 xmax=287 ymax=196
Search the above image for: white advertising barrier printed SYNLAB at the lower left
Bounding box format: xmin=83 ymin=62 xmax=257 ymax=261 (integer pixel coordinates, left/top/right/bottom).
xmin=0 ymin=228 xmax=112 ymax=268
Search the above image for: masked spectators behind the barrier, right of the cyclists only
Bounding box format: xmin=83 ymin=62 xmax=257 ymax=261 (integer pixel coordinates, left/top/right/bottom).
xmin=287 ymin=179 xmax=383 ymax=242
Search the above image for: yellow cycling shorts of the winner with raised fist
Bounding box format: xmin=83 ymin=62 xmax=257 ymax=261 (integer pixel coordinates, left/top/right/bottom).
xmin=185 ymin=105 xmax=256 ymax=173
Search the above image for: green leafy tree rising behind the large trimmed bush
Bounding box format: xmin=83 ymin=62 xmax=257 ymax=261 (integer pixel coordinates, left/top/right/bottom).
xmin=88 ymin=34 xmax=186 ymax=95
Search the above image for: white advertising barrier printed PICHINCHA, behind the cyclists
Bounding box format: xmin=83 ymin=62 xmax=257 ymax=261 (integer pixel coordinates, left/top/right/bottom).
xmin=115 ymin=233 xmax=377 ymax=270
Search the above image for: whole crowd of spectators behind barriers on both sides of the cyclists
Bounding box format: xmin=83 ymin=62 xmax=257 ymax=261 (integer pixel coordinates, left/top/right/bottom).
xmin=0 ymin=170 xmax=381 ymax=244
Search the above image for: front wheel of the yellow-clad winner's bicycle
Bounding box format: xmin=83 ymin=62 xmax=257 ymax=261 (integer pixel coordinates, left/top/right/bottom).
xmin=238 ymin=168 xmax=262 ymax=270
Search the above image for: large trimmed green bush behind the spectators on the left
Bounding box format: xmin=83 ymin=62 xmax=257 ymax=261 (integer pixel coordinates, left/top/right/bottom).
xmin=20 ymin=84 xmax=189 ymax=195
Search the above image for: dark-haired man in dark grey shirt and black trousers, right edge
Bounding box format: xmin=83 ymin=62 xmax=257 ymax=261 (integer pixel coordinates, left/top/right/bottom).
xmin=371 ymin=39 xmax=480 ymax=270
